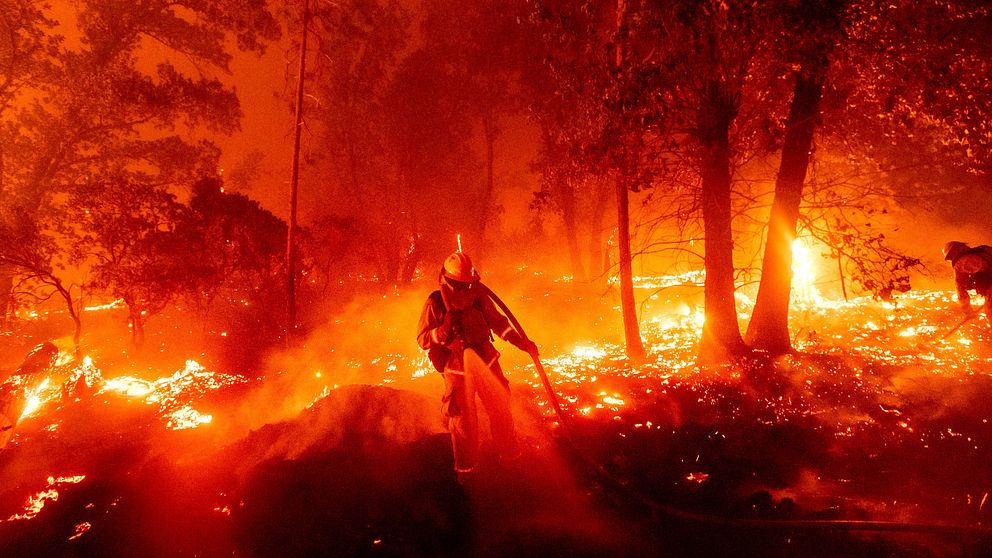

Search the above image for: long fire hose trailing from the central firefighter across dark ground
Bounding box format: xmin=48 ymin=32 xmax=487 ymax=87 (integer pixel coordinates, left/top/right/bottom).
xmin=478 ymin=282 xmax=992 ymax=537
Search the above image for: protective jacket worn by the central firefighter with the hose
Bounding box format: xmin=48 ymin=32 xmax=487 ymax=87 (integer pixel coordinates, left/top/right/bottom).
xmin=417 ymin=287 xmax=521 ymax=372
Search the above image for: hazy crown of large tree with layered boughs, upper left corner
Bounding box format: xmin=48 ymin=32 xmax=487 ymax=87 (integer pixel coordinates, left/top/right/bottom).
xmin=0 ymin=0 xmax=278 ymax=344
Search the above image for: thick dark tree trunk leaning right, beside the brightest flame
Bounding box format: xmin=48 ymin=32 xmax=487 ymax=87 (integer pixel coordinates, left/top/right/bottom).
xmin=747 ymin=65 xmax=827 ymax=355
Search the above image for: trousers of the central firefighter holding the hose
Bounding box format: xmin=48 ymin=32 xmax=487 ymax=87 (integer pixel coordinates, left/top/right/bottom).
xmin=441 ymin=349 xmax=517 ymax=472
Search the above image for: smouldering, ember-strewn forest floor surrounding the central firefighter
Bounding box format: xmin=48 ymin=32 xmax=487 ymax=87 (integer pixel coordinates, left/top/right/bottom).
xmin=0 ymin=277 xmax=992 ymax=556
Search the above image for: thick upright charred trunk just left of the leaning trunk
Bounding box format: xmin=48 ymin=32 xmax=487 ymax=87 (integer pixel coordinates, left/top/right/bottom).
xmin=699 ymin=81 xmax=747 ymax=364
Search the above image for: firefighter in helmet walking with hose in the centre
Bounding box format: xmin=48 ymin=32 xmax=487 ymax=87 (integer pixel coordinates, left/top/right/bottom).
xmin=417 ymin=251 xmax=537 ymax=473
